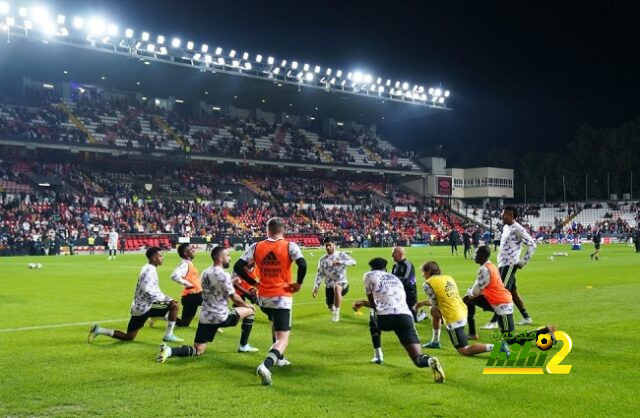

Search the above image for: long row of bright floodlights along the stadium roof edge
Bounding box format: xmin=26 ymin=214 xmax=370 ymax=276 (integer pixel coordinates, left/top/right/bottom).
xmin=0 ymin=0 xmax=451 ymax=110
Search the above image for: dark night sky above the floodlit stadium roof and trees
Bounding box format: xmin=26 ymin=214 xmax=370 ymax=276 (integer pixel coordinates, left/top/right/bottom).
xmin=53 ymin=0 xmax=640 ymax=160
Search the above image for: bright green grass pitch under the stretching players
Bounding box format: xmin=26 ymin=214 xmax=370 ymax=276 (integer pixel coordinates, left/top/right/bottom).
xmin=0 ymin=245 xmax=640 ymax=417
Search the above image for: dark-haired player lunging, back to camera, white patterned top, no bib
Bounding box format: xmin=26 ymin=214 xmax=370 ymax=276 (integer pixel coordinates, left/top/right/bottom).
xmin=353 ymin=257 xmax=444 ymax=383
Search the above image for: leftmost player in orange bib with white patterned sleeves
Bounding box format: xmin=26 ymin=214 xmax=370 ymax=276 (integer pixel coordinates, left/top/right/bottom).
xmin=171 ymin=243 xmax=202 ymax=327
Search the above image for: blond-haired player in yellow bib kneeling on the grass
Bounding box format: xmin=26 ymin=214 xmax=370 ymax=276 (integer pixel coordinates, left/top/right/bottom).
xmin=416 ymin=261 xmax=508 ymax=356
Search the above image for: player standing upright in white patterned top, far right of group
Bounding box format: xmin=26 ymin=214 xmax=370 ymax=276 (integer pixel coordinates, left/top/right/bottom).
xmin=482 ymin=206 xmax=536 ymax=329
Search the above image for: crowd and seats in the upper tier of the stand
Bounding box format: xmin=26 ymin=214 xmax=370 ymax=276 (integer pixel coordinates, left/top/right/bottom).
xmin=0 ymin=88 xmax=420 ymax=170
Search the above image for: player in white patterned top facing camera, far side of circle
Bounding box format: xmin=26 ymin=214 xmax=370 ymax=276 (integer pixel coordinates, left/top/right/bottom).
xmin=311 ymin=237 xmax=356 ymax=322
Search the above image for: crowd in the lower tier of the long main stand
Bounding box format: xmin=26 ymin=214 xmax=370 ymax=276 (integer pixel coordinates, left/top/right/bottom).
xmin=0 ymin=161 xmax=461 ymax=255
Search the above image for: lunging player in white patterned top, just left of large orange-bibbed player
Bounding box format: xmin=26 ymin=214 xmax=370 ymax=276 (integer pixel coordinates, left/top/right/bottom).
xmin=157 ymin=246 xmax=255 ymax=363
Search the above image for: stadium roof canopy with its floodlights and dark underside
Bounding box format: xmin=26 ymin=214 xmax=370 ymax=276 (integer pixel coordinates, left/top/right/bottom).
xmin=0 ymin=2 xmax=449 ymax=123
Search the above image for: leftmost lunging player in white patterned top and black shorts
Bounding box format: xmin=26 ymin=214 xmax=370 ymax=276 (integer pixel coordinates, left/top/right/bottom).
xmin=88 ymin=247 xmax=184 ymax=343
